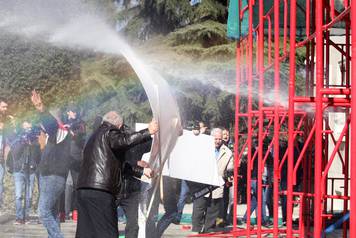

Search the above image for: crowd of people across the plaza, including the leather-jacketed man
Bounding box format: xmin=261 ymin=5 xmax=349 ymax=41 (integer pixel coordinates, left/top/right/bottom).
xmin=0 ymin=91 xmax=292 ymax=238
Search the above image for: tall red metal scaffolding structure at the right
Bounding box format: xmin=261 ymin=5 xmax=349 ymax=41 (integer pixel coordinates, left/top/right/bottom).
xmin=191 ymin=0 xmax=356 ymax=237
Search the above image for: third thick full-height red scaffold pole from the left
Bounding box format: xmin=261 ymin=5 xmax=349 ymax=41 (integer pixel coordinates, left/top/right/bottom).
xmin=287 ymin=0 xmax=297 ymax=237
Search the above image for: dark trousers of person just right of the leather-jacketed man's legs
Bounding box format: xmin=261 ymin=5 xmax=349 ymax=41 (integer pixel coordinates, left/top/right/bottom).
xmin=119 ymin=192 xmax=140 ymax=238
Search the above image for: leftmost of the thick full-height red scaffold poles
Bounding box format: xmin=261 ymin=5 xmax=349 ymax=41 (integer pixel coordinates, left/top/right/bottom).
xmin=246 ymin=0 xmax=253 ymax=237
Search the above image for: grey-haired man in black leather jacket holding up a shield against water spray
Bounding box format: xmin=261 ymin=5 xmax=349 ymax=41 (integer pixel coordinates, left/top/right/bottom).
xmin=76 ymin=111 xmax=158 ymax=238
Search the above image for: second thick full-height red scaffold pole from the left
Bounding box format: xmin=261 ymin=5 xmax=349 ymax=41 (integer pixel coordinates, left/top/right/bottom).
xmin=273 ymin=0 xmax=280 ymax=237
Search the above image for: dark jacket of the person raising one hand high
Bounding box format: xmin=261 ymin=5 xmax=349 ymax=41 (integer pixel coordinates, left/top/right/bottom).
xmin=39 ymin=112 xmax=72 ymax=178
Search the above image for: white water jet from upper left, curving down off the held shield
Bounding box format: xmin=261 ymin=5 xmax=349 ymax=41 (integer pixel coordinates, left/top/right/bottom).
xmin=0 ymin=0 xmax=181 ymax=178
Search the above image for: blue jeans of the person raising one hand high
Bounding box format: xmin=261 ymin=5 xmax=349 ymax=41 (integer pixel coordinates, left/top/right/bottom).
xmin=38 ymin=175 xmax=65 ymax=238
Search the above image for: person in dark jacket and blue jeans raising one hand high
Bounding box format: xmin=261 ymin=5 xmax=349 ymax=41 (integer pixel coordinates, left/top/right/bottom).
xmin=31 ymin=90 xmax=78 ymax=238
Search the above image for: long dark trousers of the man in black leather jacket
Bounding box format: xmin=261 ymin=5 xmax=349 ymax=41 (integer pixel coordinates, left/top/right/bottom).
xmin=75 ymin=189 xmax=119 ymax=238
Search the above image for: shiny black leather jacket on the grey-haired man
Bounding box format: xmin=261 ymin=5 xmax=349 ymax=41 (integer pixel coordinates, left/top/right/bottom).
xmin=78 ymin=122 xmax=150 ymax=196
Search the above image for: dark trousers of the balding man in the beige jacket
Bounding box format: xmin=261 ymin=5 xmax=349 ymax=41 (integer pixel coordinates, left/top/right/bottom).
xmin=192 ymin=197 xmax=223 ymax=232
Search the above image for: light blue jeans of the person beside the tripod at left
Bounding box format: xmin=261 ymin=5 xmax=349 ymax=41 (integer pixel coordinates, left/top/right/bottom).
xmin=13 ymin=172 xmax=35 ymax=220
